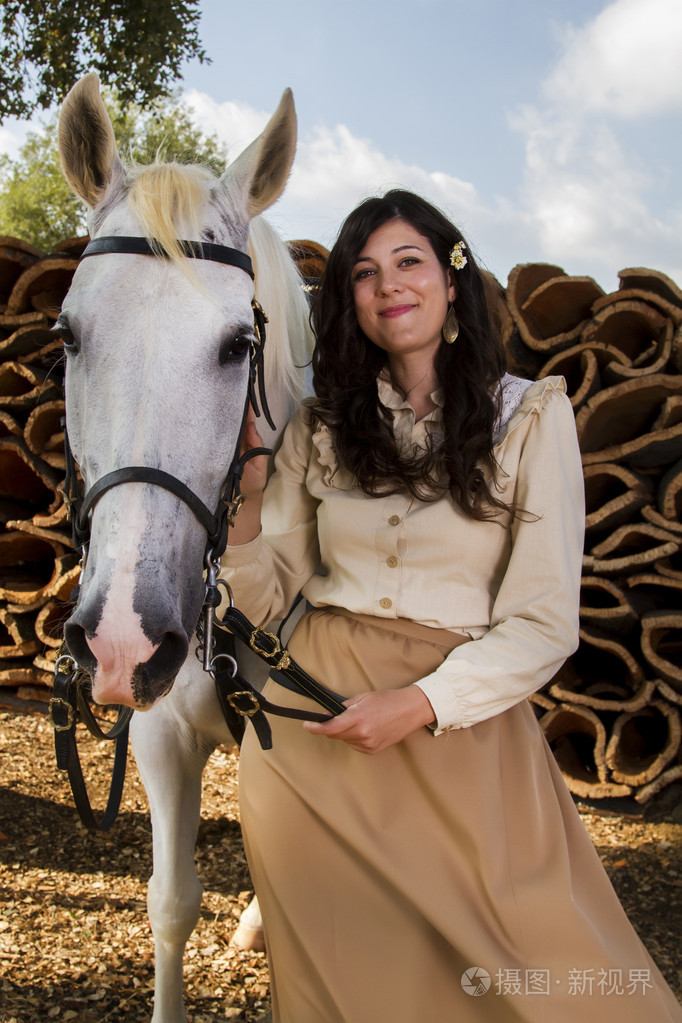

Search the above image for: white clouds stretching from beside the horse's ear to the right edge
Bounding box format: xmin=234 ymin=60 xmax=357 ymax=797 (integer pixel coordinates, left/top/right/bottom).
xmin=180 ymin=7 xmax=682 ymax=290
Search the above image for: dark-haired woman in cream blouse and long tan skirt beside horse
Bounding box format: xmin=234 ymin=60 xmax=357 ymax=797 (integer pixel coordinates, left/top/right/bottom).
xmin=225 ymin=191 xmax=682 ymax=1023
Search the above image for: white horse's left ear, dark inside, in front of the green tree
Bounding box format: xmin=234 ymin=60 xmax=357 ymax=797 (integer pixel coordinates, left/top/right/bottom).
xmin=59 ymin=72 xmax=123 ymax=209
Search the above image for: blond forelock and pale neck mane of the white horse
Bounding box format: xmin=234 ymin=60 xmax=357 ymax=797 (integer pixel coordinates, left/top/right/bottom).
xmin=129 ymin=163 xmax=313 ymax=403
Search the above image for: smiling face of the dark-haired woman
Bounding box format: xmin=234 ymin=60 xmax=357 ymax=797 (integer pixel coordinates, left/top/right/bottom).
xmin=352 ymin=220 xmax=455 ymax=368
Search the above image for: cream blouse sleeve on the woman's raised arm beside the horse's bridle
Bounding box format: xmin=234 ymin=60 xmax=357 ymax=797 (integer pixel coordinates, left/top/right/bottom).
xmin=221 ymin=406 xmax=320 ymax=625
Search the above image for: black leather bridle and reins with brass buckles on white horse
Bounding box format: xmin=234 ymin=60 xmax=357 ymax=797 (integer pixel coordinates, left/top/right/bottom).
xmin=50 ymin=235 xmax=345 ymax=831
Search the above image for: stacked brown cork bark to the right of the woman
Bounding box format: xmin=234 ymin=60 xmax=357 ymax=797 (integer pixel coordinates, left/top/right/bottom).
xmin=498 ymin=264 xmax=682 ymax=803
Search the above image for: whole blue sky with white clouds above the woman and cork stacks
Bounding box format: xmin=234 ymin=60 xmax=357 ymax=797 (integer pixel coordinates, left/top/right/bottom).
xmin=0 ymin=0 xmax=682 ymax=291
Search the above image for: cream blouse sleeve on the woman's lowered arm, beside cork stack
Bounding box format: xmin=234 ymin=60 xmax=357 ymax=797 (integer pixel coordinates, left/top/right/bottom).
xmin=415 ymin=377 xmax=585 ymax=733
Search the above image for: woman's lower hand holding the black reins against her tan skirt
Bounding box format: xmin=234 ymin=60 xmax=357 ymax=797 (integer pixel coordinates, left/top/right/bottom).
xmin=304 ymin=685 xmax=436 ymax=754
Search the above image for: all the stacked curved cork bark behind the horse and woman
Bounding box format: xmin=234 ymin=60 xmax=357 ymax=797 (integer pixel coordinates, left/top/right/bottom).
xmin=0 ymin=237 xmax=682 ymax=803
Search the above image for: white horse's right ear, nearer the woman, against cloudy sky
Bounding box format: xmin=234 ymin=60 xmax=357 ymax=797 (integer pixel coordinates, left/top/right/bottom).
xmin=223 ymin=89 xmax=297 ymax=219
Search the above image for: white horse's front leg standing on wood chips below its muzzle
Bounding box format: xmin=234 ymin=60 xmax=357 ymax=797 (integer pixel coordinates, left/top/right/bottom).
xmin=131 ymin=695 xmax=215 ymax=1023
